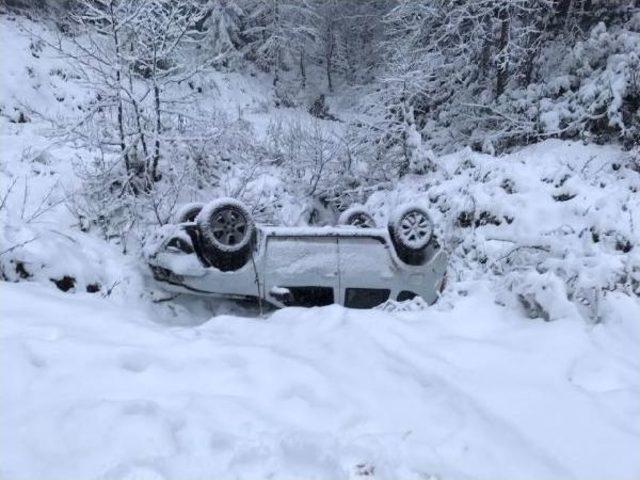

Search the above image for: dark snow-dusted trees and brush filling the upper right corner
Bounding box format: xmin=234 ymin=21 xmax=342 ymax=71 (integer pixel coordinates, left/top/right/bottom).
xmin=376 ymin=0 xmax=640 ymax=155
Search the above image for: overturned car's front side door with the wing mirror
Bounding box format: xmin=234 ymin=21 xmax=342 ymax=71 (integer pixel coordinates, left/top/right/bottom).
xmin=264 ymin=236 xmax=339 ymax=306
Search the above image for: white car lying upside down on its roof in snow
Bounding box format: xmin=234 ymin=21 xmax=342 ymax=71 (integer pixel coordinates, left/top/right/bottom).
xmin=146 ymin=198 xmax=447 ymax=308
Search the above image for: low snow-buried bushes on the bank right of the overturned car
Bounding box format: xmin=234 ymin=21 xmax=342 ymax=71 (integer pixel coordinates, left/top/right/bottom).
xmin=367 ymin=140 xmax=640 ymax=321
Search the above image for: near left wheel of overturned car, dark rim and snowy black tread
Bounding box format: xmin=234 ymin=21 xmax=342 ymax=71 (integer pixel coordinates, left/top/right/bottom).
xmin=196 ymin=198 xmax=256 ymax=271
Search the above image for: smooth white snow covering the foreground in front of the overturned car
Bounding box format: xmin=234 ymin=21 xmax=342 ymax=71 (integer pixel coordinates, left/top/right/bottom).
xmin=0 ymin=282 xmax=640 ymax=480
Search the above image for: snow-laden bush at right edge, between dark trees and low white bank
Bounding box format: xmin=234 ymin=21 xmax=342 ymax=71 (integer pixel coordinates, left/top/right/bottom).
xmin=472 ymin=22 xmax=640 ymax=150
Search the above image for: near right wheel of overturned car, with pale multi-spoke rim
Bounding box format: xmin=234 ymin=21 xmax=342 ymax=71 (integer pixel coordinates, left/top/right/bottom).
xmin=389 ymin=204 xmax=433 ymax=265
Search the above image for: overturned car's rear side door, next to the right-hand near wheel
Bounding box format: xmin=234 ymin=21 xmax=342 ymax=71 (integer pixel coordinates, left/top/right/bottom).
xmin=338 ymin=236 xmax=396 ymax=308
